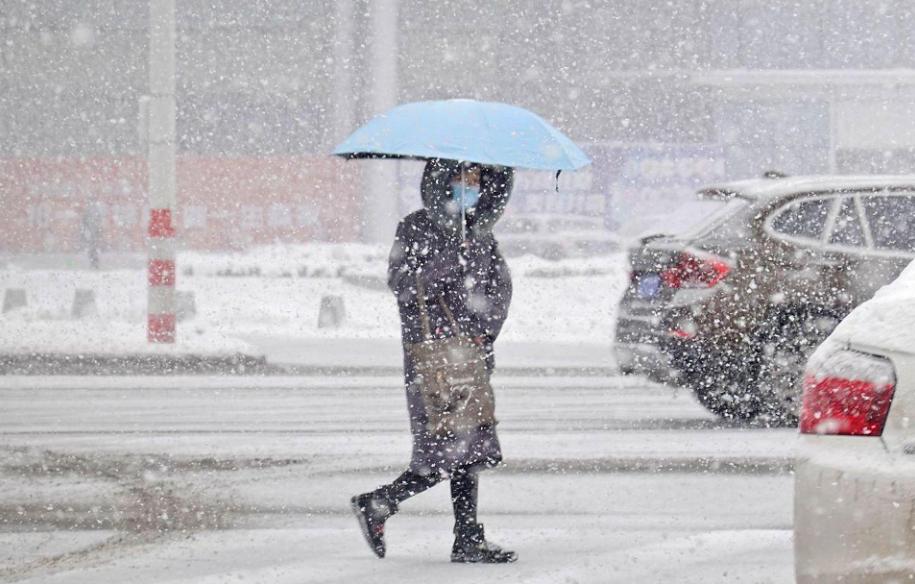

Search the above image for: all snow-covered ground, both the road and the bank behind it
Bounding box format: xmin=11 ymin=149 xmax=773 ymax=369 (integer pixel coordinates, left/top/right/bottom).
xmin=0 ymin=246 xmax=794 ymax=584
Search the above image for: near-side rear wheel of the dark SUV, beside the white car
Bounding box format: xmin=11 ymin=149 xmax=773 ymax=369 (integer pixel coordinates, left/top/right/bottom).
xmin=758 ymin=313 xmax=839 ymax=426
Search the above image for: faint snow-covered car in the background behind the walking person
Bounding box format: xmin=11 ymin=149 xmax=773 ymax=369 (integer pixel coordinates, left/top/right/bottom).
xmin=496 ymin=215 xmax=621 ymax=260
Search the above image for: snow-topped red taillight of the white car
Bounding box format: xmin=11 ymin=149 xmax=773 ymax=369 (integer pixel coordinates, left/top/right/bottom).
xmin=800 ymin=350 xmax=896 ymax=436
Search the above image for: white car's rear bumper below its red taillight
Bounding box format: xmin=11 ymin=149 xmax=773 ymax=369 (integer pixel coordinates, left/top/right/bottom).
xmin=794 ymin=435 xmax=915 ymax=584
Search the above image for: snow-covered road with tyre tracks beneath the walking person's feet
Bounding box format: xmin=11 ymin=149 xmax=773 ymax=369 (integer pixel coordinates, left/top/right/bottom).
xmin=0 ymin=377 xmax=794 ymax=584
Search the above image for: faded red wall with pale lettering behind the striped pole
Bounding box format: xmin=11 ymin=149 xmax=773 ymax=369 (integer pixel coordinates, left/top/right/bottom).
xmin=0 ymin=156 xmax=362 ymax=252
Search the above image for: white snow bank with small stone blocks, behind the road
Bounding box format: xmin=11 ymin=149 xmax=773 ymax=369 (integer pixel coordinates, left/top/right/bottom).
xmin=0 ymin=244 xmax=627 ymax=365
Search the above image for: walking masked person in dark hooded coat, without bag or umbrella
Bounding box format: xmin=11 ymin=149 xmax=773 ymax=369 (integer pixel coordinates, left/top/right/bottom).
xmin=351 ymin=159 xmax=517 ymax=563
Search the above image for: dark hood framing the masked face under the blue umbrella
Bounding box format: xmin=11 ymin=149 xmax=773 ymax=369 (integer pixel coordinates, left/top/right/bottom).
xmin=420 ymin=159 xmax=515 ymax=237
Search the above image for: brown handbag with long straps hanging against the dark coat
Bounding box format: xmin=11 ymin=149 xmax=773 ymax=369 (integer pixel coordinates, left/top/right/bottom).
xmin=407 ymin=276 xmax=496 ymax=437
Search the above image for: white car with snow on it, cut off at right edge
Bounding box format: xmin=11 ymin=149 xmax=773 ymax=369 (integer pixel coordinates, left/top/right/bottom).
xmin=794 ymin=263 xmax=915 ymax=583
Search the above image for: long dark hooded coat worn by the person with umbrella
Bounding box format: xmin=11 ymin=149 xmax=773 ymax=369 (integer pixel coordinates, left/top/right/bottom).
xmin=388 ymin=160 xmax=513 ymax=475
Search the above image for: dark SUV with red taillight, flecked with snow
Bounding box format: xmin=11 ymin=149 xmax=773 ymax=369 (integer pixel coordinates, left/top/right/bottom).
xmin=616 ymin=176 xmax=915 ymax=424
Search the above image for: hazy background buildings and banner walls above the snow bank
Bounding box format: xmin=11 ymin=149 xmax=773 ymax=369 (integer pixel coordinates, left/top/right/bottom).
xmin=0 ymin=0 xmax=915 ymax=253
